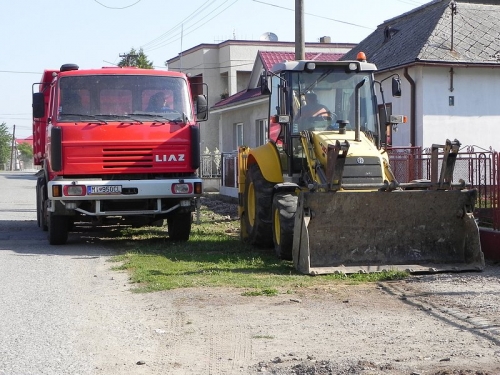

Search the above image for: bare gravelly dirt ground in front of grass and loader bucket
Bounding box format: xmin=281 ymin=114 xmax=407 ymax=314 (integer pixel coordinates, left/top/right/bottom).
xmin=90 ymin=198 xmax=500 ymax=375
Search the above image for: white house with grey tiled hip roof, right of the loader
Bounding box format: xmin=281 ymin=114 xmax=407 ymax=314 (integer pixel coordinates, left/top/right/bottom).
xmin=342 ymin=0 xmax=500 ymax=150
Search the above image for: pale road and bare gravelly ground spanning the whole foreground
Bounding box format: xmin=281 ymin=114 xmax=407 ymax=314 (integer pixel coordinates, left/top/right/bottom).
xmin=0 ymin=177 xmax=500 ymax=375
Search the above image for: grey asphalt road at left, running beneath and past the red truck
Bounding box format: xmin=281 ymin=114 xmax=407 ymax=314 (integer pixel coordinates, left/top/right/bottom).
xmin=0 ymin=172 xmax=160 ymax=375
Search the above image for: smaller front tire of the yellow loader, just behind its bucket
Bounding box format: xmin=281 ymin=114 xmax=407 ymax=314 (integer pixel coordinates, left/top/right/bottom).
xmin=272 ymin=193 xmax=297 ymax=260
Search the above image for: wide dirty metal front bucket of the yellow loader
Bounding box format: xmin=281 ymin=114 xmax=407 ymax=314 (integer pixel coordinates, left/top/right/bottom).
xmin=293 ymin=190 xmax=484 ymax=275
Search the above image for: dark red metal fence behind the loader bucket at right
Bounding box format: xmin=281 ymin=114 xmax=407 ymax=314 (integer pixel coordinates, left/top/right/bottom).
xmin=387 ymin=146 xmax=500 ymax=230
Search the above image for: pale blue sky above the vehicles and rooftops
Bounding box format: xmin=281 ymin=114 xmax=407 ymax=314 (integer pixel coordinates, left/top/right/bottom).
xmin=0 ymin=0 xmax=430 ymax=139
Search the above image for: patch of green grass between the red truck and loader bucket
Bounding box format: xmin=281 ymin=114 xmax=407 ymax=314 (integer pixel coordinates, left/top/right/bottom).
xmin=107 ymin=200 xmax=408 ymax=296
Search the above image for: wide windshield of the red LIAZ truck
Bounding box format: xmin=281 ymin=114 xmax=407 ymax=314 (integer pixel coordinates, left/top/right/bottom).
xmin=57 ymin=75 xmax=193 ymax=122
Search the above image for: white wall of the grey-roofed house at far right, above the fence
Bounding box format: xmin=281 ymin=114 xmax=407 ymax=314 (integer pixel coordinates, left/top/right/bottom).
xmin=423 ymin=67 xmax=500 ymax=150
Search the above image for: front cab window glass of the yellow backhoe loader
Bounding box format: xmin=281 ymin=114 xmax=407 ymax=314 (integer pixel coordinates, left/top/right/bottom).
xmin=291 ymin=66 xmax=378 ymax=134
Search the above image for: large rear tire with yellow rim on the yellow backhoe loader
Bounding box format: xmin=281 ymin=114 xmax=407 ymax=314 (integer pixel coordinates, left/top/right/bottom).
xmin=242 ymin=164 xmax=274 ymax=247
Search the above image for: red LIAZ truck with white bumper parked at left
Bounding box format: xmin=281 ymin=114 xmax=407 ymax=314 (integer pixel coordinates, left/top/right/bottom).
xmin=33 ymin=64 xmax=208 ymax=245
